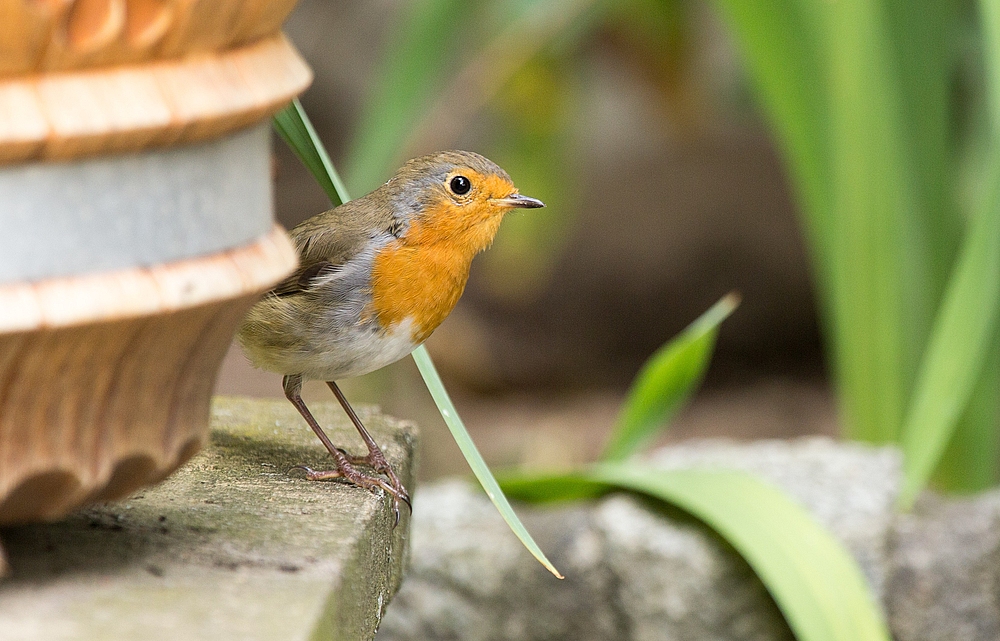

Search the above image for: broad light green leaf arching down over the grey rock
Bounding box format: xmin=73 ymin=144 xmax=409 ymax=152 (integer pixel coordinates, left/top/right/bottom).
xmin=503 ymin=463 xmax=890 ymax=641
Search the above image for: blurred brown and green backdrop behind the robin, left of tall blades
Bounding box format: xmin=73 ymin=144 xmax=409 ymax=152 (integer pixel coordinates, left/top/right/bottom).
xmin=217 ymin=0 xmax=837 ymax=479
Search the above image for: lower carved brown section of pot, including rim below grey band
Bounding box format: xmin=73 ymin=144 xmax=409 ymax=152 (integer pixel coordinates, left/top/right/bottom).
xmin=0 ymin=228 xmax=296 ymax=524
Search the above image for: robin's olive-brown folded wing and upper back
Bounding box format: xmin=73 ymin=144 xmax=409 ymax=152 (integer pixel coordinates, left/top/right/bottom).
xmin=271 ymin=188 xmax=393 ymax=296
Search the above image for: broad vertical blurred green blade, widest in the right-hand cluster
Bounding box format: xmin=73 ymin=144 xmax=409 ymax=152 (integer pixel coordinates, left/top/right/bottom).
xmin=828 ymin=0 xmax=920 ymax=442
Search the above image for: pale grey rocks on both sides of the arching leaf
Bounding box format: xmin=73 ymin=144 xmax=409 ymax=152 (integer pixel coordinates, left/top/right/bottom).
xmin=378 ymin=439 xmax=899 ymax=641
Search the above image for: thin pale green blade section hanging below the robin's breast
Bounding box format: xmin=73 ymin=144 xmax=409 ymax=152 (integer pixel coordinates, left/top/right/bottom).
xmin=413 ymin=345 xmax=563 ymax=579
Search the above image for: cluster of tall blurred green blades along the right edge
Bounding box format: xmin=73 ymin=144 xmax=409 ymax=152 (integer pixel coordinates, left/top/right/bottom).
xmin=718 ymin=0 xmax=1000 ymax=504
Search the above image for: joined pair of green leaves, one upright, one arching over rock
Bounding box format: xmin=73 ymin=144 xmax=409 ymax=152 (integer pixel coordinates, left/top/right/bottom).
xmin=501 ymin=294 xmax=890 ymax=641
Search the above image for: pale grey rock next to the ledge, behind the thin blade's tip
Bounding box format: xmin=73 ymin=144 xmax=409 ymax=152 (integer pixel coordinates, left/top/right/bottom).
xmin=378 ymin=481 xmax=622 ymax=641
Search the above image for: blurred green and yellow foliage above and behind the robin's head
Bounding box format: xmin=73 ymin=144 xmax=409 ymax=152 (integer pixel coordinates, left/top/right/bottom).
xmin=346 ymin=0 xmax=697 ymax=302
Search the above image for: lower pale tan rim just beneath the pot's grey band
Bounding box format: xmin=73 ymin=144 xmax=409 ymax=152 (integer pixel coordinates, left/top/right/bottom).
xmin=0 ymin=225 xmax=298 ymax=334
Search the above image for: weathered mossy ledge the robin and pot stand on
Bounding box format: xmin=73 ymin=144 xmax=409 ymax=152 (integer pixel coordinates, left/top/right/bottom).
xmin=0 ymin=398 xmax=416 ymax=641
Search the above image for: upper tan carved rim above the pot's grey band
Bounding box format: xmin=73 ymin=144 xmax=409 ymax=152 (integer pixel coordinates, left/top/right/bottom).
xmin=0 ymin=33 xmax=312 ymax=163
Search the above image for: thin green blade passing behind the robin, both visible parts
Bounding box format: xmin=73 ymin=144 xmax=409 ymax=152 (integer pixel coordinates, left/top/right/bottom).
xmin=274 ymin=99 xmax=563 ymax=579
